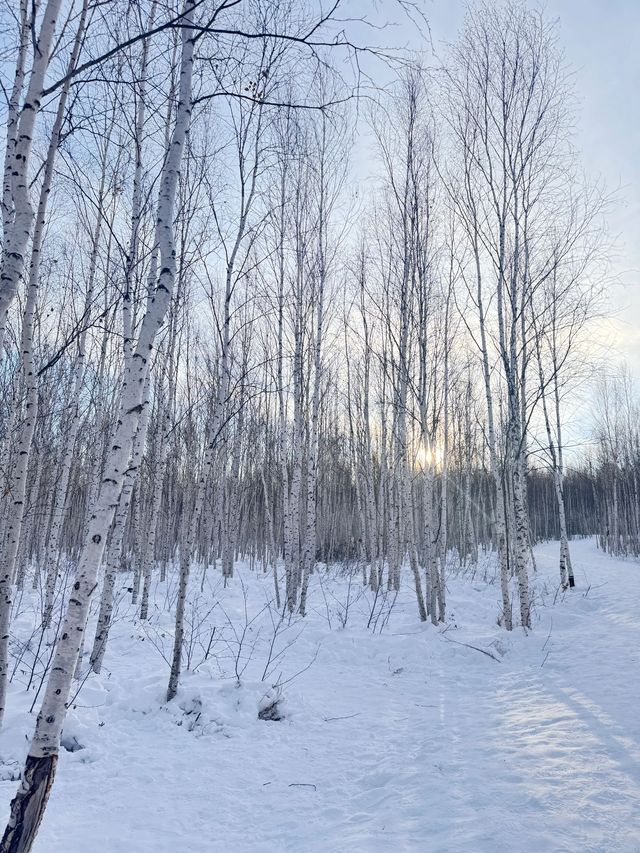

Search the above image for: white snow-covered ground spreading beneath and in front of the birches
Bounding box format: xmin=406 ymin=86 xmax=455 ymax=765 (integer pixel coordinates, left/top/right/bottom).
xmin=0 ymin=541 xmax=640 ymax=853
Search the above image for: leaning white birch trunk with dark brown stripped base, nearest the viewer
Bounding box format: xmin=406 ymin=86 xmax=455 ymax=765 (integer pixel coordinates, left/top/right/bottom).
xmin=0 ymin=5 xmax=195 ymax=853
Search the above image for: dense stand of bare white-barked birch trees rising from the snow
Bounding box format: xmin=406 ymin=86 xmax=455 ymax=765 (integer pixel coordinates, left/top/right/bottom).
xmin=0 ymin=0 xmax=640 ymax=851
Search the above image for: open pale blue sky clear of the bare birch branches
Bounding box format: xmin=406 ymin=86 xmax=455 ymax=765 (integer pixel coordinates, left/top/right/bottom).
xmin=349 ymin=0 xmax=640 ymax=366
